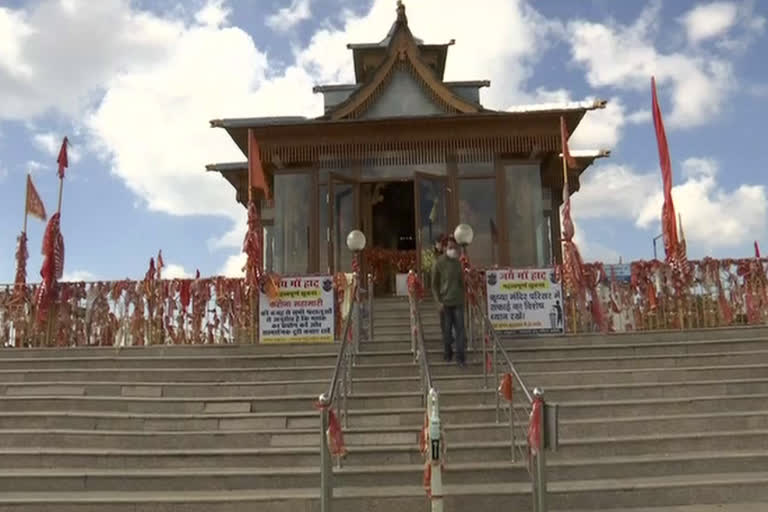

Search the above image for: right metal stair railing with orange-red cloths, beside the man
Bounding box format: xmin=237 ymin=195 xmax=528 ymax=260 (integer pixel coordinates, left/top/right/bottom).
xmin=467 ymin=271 xmax=558 ymax=512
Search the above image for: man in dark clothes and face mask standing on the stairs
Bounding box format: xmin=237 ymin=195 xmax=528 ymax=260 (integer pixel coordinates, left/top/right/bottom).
xmin=432 ymin=236 xmax=465 ymax=367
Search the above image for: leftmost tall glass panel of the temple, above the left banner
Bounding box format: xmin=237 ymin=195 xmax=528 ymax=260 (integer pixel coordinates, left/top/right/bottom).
xmin=273 ymin=173 xmax=313 ymax=274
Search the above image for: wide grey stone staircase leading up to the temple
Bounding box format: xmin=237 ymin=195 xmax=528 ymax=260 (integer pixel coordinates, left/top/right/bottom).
xmin=0 ymin=299 xmax=768 ymax=512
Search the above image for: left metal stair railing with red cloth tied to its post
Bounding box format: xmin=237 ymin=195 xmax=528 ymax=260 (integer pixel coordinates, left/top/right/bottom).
xmin=317 ymin=275 xmax=362 ymax=512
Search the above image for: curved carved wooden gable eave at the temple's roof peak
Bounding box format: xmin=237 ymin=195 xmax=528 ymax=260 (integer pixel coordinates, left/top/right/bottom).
xmin=321 ymin=4 xmax=483 ymax=120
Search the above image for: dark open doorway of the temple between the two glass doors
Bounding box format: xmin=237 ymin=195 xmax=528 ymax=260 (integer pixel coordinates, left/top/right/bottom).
xmin=361 ymin=181 xmax=417 ymax=295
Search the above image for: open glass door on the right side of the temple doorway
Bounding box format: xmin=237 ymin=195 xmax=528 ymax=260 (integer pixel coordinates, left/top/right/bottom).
xmin=413 ymin=172 xmax=448 ymax=275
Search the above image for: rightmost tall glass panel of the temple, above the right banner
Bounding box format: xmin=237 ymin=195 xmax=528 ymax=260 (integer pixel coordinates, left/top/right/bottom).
xmin=504 ymin=163 xmax=550 ymax=267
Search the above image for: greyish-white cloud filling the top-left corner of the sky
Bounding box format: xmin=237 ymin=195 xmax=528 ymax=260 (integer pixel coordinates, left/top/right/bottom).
xmin=0 ymin=0 xmax=182 ymax=120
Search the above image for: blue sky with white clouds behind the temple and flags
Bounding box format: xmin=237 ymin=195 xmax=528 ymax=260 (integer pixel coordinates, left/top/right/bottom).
xmin=0 ymin=0 xmax=768 ymax=282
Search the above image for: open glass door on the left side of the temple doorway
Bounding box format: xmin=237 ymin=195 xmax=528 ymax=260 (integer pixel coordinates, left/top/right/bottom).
xmin=327 ymin=173 xmax=360 ymax=274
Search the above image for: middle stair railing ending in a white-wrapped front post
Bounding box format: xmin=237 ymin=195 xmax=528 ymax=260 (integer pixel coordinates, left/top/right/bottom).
xmin=408 ymin=270 xmax=445 ymax=512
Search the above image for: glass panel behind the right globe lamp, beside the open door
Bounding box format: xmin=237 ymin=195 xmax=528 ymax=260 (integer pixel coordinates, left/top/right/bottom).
xmin=459 ymin=178 xmax=499 ymax=267
